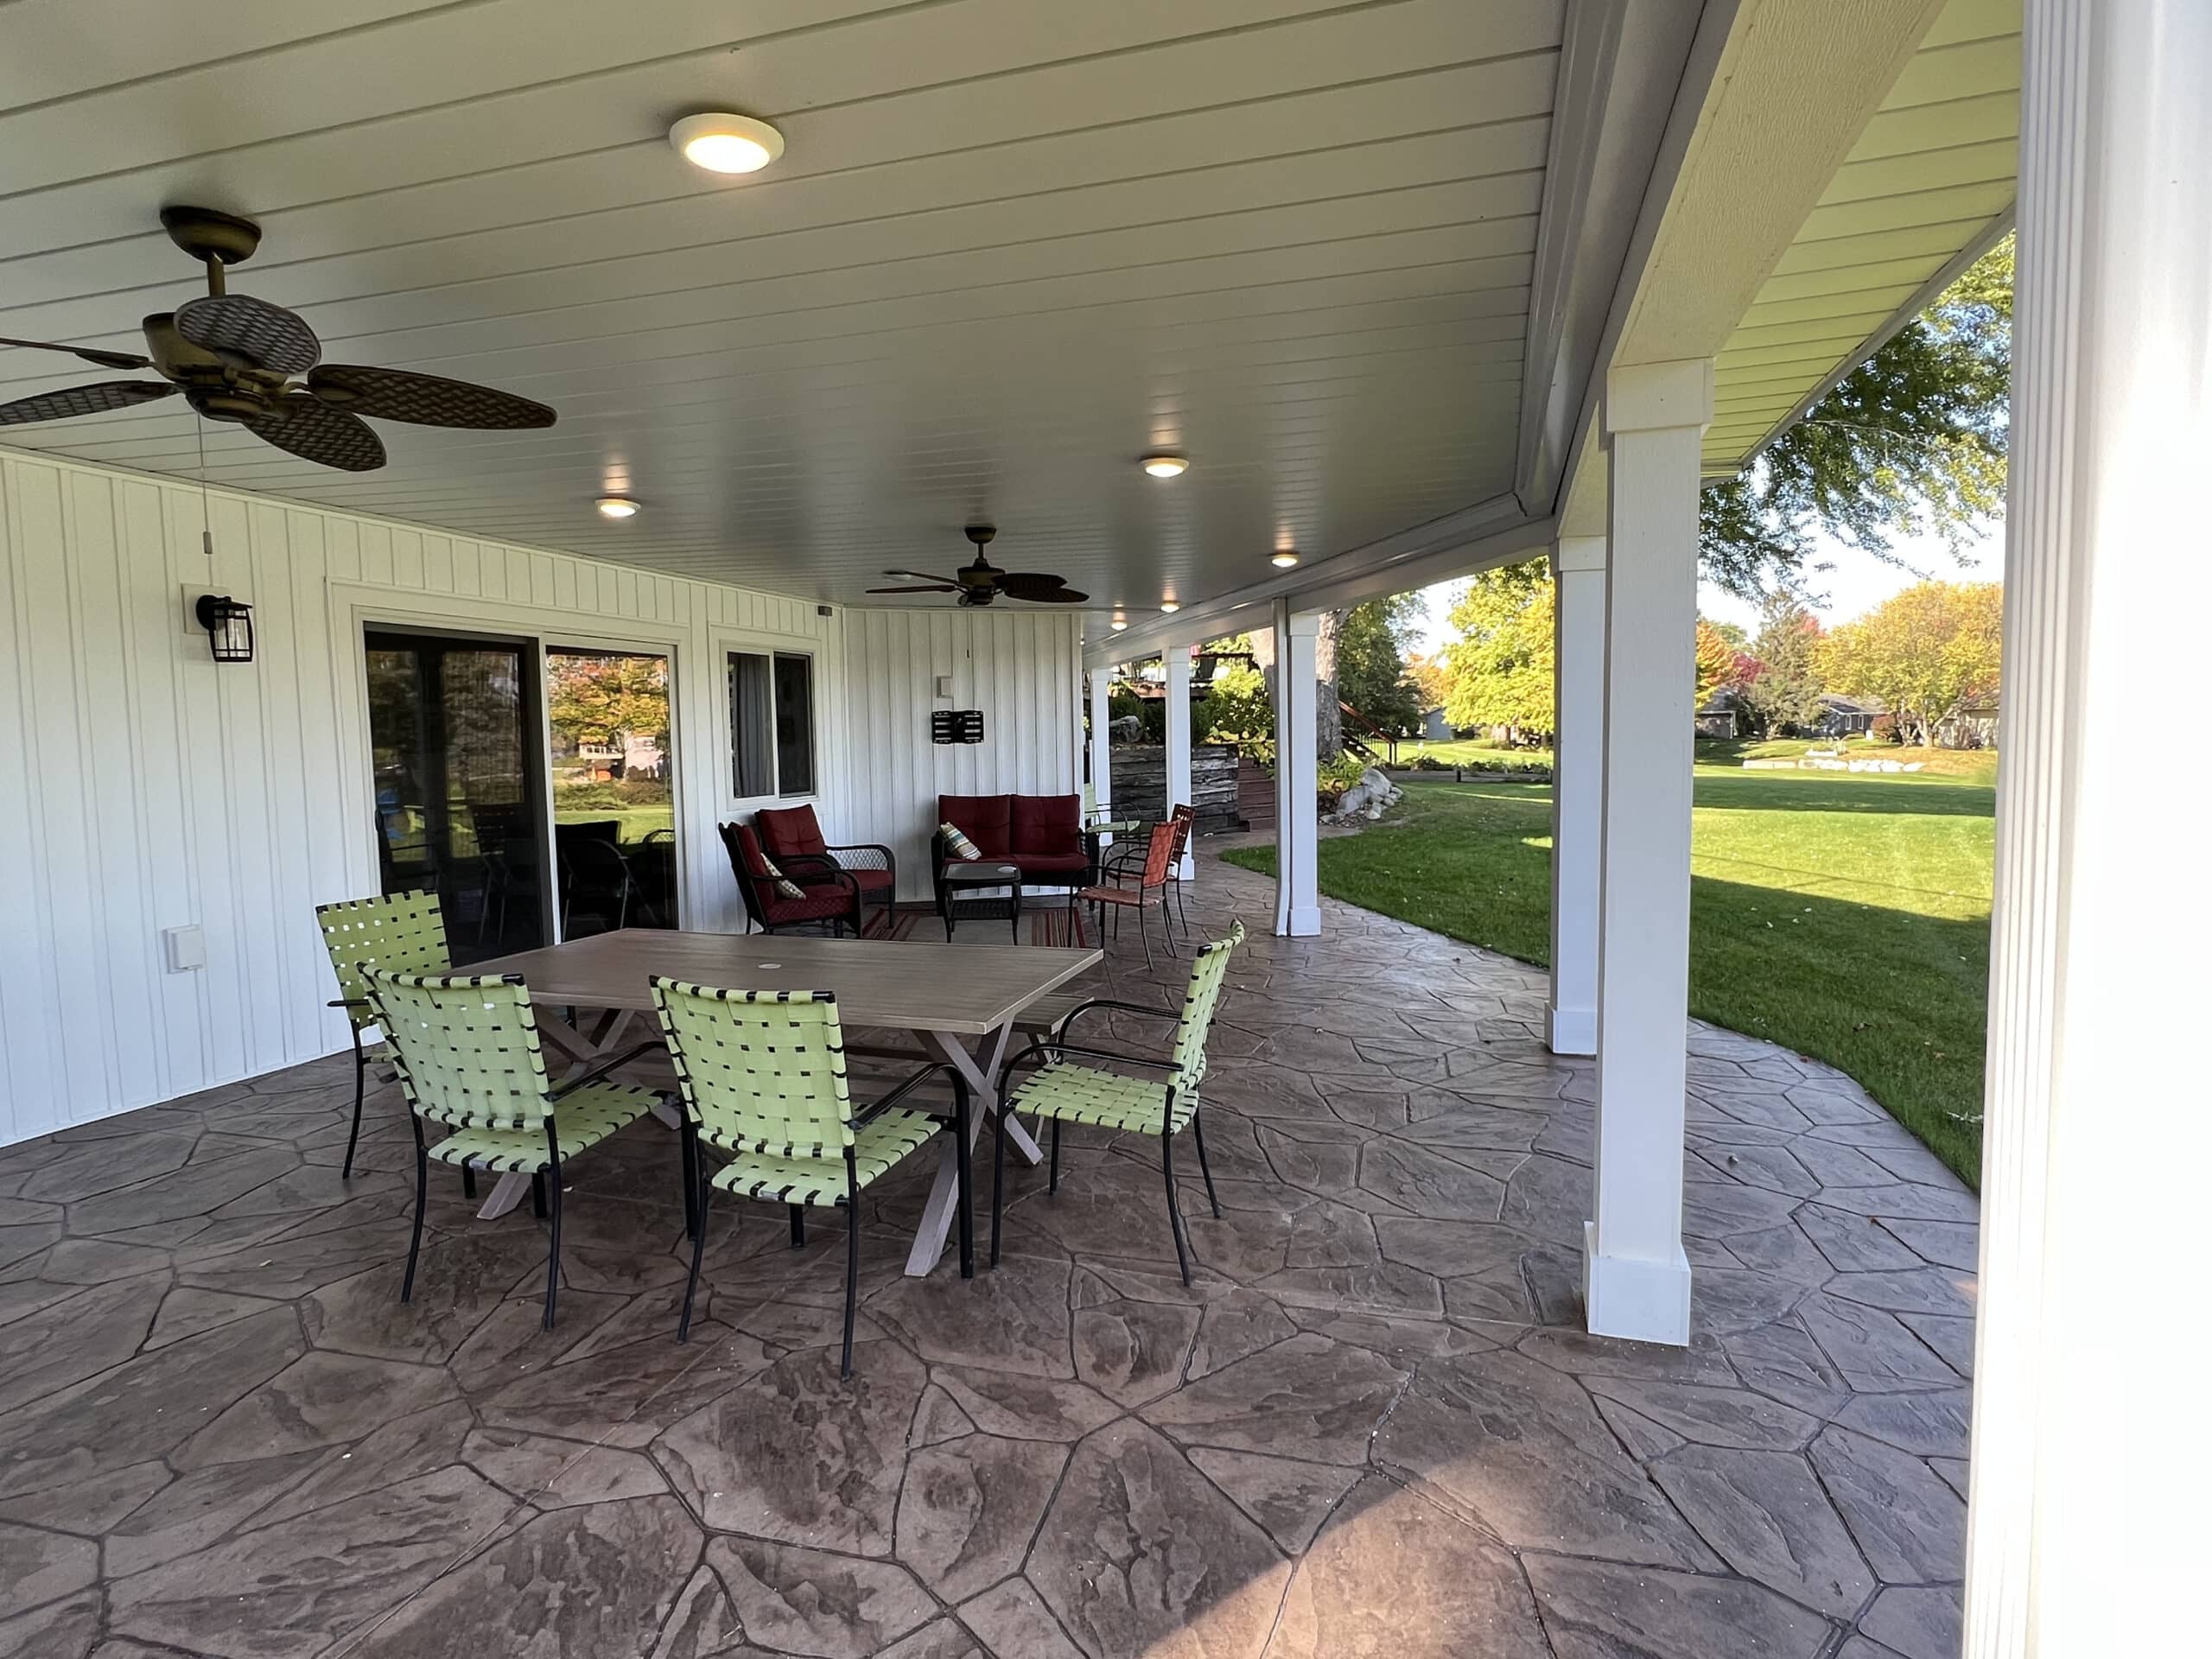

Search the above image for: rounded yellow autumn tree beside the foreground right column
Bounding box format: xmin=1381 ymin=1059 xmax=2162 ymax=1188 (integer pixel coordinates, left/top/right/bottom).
xmin=1814 ymin=582 xmax=2004 ymax=746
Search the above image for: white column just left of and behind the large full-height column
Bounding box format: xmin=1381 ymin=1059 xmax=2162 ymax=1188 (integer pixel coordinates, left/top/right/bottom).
xmin=1544 ymin=536 xmax=1606 ymax=1055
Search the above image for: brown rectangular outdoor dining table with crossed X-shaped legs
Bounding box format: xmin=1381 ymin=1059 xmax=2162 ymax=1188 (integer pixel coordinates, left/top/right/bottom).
xmin=469 ymin=927 xmax=1103 ymax=1276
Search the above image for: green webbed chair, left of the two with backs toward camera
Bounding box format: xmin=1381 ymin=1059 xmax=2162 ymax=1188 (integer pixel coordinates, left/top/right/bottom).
xmin=360 ymin=964 xmax=659 ymax=1330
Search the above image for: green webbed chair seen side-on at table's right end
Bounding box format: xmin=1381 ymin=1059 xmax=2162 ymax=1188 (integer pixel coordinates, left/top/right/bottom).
xmin=991 ymin=923 xmax=1245 ymax=1285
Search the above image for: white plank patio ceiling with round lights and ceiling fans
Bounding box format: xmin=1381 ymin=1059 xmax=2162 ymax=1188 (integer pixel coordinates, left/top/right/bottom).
xmin=0 ymin=0 xmax=1566 ymax=608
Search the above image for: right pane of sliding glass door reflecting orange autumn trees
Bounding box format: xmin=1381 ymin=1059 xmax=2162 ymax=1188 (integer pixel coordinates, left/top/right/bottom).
xmin=546 ymin=646 xmax=677 ymax=938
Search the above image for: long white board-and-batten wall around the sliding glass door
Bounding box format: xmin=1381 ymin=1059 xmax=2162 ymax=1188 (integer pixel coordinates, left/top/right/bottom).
xmin=0 ymin=451 xmax=844 ymax=1144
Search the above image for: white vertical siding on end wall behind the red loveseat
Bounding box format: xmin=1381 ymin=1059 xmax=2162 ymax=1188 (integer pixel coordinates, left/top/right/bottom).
xmin=845 ymin=606 xmax=1084 ymax=900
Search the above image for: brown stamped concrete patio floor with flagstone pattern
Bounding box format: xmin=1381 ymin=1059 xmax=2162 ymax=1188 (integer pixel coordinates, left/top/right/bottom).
xmin=0 ymin=865 xmax=1975 ymax=1659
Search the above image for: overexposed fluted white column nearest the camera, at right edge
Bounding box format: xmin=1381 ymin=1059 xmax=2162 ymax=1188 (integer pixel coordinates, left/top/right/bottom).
xmin=1964 ymin=0 xmax=2212 ymax=1659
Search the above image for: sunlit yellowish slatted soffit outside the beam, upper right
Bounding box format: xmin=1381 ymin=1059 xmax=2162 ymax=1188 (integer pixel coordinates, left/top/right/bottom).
xmin=1706 ymin=0 xmax=2019 ymax=478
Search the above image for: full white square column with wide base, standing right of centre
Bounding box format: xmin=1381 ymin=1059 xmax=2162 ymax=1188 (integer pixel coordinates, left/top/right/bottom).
xmin=1584 ymin=359 xmax=1712 ymax=1343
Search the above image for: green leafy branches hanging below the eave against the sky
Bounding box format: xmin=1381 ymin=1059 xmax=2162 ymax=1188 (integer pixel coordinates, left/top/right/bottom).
xmin=1699 ymin=237 xmax=2013 ymax=600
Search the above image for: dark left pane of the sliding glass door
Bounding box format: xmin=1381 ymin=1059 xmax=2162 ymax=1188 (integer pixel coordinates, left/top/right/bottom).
xmin=365 ymin=632 xmax=546 ymax=964
